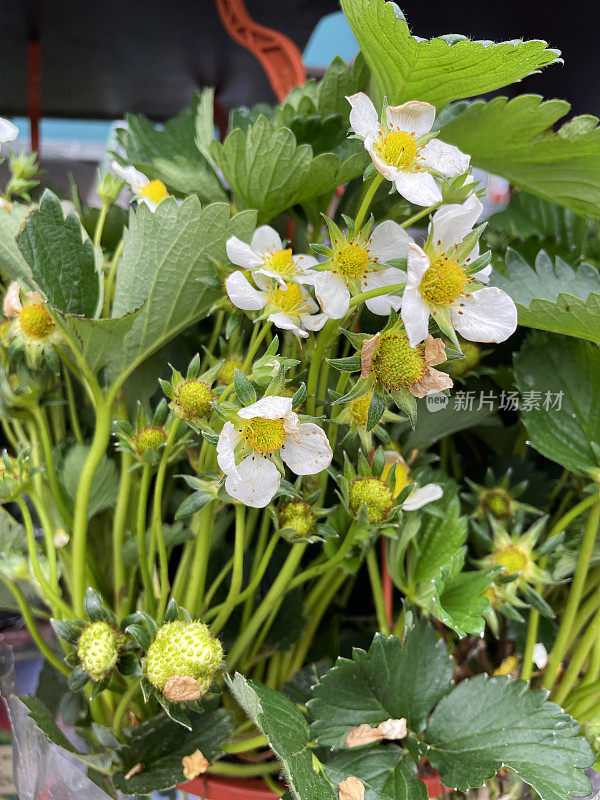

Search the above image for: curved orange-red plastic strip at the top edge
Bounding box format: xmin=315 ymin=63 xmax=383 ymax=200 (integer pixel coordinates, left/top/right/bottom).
xmin=215 ymin=0 xmax=306 ymax=102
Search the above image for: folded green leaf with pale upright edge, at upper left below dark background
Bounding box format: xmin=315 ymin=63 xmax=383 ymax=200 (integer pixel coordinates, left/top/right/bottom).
xmin=115 ymin=90 xmax=227 ymax=202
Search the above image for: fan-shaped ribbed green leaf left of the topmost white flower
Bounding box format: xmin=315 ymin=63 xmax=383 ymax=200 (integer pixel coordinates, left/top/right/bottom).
xmin=211 ymin=116 xmax=365 ymax=222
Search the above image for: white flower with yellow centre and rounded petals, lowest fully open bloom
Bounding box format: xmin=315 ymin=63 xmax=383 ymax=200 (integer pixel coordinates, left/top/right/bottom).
xmin=217 ymin=395 xmax=333 ymax=508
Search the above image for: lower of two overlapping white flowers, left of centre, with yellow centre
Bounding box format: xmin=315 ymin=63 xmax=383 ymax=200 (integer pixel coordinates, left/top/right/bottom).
xmin=225 ymin=270 xmax=327 ymax=338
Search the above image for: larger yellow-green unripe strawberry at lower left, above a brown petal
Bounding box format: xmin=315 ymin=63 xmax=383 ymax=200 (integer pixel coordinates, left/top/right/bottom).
xmin=145 ymin=620 xmax=223 ymax=694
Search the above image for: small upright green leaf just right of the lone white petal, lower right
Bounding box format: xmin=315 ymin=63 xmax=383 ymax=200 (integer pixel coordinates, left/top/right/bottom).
xmin=412 ymin=491 xmax=467 ymax=582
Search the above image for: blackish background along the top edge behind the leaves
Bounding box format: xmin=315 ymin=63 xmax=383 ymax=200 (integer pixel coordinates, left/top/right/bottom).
xmin=0 ymin=0 xmax=600 ymax=119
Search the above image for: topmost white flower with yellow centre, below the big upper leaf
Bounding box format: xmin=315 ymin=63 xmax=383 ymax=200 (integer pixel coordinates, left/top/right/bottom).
xmin=346 ymin=92 xmax=470 ymax=206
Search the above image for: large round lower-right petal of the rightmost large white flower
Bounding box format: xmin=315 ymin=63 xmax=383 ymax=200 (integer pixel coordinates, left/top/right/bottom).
xmin=451 ymin=286 xmax=517 ymax=342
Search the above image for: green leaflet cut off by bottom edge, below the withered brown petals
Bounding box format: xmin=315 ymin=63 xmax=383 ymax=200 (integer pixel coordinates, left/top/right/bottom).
xmin=324 ymin=745 xmax=427 ymax=800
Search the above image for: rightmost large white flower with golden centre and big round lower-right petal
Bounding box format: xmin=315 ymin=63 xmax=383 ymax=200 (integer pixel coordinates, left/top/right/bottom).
xmin=401 ymin=195 xmax=517 ymax=347
